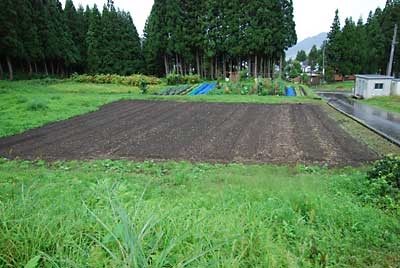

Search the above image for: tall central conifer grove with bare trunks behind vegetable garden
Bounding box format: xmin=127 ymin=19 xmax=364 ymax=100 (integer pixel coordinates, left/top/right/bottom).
xmin=143 ymin=0 xmax=297 ymax=79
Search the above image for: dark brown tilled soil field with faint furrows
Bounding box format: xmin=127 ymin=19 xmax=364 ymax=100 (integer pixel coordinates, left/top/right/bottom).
xmin=0 ymin=101 xmax=378 ymax=166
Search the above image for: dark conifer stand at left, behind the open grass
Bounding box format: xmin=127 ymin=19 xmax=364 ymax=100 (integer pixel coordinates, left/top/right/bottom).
xmin=0 ymin=0 xmax=143 ymax=79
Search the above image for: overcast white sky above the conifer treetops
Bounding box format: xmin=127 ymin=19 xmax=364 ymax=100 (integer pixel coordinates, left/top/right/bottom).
xmin=70 ymin=0 xmax=386 ymax=41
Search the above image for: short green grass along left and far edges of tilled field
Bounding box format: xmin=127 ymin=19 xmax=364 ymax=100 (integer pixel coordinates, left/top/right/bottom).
xmin=0 ymin=80 xmax=317 ymax=137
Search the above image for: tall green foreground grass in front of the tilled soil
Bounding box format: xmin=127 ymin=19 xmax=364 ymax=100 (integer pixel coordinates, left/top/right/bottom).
xmin=0 ymin=160 xmax=400 ymax=267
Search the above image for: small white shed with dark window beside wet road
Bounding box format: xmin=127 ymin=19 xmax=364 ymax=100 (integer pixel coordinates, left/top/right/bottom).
xmin=354 ymin=74 xmax=393 ymax=99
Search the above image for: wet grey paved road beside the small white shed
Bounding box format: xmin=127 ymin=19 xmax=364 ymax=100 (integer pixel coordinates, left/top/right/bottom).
xmin=316 ymin=91 xmax=400 ymax=146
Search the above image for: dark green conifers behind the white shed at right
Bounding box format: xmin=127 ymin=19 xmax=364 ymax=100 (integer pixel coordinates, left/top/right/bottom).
xmin=326 ymin=1 xmax=400 ymax=76
